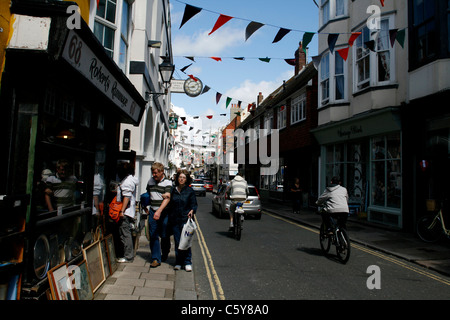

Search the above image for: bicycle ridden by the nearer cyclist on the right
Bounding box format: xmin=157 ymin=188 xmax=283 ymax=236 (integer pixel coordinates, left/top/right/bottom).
xmin=319 ymin=212 xmax=351 ymax=264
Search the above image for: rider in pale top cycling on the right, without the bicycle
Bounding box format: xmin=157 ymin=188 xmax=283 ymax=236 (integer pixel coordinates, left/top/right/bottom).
xmin=316 ymin=176 xmax=349 ymax=234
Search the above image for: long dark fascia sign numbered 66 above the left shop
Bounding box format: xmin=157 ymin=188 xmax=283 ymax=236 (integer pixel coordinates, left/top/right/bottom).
xmin=62 ymin=30 xmax=139 ymax=122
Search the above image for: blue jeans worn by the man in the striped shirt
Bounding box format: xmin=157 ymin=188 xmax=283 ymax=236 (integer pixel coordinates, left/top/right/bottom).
xmin=148 ymin=208 xmax=170 ymax=263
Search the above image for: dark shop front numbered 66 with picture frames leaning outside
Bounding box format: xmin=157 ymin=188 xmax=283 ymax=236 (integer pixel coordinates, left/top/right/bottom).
xmin=0 ymin=5 xmax=146 ymax=299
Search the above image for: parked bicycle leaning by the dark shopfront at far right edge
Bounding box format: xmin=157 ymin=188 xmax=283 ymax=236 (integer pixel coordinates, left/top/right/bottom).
xmin=416 ymin=204 xmax=450 ymax=243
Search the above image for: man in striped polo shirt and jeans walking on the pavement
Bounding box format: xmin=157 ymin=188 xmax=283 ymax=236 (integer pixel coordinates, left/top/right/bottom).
xmin=147 ymin=162 xmax=172 ymax=268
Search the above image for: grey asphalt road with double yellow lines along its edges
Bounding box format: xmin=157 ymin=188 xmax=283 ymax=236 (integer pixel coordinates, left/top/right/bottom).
xmin=193 ymin=193 xmax=450 ymax=300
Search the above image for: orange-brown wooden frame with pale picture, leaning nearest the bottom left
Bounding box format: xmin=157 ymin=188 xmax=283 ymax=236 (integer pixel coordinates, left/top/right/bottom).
xmin=47 ymin=262 xmax=75 ymax=300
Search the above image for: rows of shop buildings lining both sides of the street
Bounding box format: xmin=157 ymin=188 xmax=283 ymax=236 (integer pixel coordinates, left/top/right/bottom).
xmin=0 ymin=0 xmax=450 ymax=300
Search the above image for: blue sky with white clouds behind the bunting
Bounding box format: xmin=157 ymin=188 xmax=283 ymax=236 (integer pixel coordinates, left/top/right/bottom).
xmin=171 ymin=0 xmax=319 ymax=142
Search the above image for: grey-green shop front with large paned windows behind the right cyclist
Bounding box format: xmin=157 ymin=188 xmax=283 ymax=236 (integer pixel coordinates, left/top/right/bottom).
xmin=313 ymin=108 xmax=403 ymax=229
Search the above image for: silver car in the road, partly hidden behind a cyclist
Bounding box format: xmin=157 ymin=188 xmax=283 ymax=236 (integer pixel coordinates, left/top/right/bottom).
xmin=212 ymin=184 xmax=261 ymax=219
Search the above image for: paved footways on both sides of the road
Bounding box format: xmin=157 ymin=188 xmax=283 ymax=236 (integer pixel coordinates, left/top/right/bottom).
xmin=94 ymin=198 xmax=450 ymax=300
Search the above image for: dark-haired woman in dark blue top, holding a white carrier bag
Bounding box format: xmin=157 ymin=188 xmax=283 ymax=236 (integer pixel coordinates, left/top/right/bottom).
xmin=169 ymin=170 xmax=197 ymax=272
